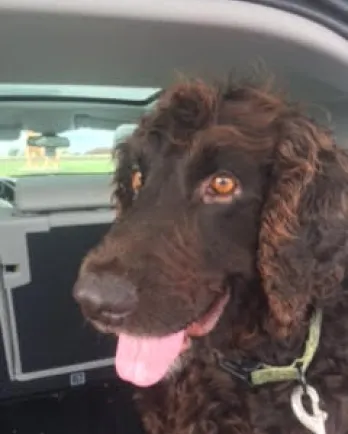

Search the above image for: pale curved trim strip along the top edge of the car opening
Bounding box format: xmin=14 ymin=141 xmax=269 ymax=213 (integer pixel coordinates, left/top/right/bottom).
xmin=0 ymin=0 xmax=348 ymax=65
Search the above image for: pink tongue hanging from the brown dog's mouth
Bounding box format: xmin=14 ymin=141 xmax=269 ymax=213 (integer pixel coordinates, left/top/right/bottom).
xmin=116 ymin=330 xmax=185 ymax=387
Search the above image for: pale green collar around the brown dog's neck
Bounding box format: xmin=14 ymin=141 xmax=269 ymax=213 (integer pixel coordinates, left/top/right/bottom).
xmin=218 ymin=309 xmax=323 ymax=386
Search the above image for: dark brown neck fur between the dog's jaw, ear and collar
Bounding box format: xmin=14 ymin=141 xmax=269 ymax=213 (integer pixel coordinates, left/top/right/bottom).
xmin=209 ymin=283 xmax=311 ymax=372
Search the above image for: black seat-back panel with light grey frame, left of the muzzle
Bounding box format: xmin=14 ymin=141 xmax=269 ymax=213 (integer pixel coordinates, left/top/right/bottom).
xmin=0 ymin=210 xmax=114 ymax=381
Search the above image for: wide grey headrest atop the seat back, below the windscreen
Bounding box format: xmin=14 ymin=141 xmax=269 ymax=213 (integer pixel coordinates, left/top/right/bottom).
xmin=14 ymin=174 xmax=112 ymax=213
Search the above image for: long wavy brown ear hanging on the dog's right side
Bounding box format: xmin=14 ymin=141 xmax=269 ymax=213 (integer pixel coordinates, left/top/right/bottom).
xmin=258 ymin=114 xmax=348 ymax=336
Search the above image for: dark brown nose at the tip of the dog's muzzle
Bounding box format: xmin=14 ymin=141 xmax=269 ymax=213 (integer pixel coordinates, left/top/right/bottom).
xmin=74 ymin=273 xmax=138 ymax=323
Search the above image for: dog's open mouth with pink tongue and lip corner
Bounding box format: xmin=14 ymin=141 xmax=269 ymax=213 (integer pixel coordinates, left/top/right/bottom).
xmin=115 ymin=295 xmax=229 ymax=387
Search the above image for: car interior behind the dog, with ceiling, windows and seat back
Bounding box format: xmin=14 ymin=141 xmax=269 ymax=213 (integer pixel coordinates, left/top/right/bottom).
xmin=0 ymin=0 xmax=348 ymax=434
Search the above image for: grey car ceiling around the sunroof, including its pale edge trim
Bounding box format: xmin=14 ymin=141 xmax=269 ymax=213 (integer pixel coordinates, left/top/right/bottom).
xmin=0 ymin=0 xmax=348 ymax=134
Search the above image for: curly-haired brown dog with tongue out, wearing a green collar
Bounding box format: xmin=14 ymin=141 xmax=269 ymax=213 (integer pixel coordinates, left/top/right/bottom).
xmin=74 ymin=80 xmax=348 ymax=434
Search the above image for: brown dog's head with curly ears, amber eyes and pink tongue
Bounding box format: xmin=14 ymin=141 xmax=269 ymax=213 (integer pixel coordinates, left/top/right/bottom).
xmin=74 ymin=81 xmax=348 ymax=386
